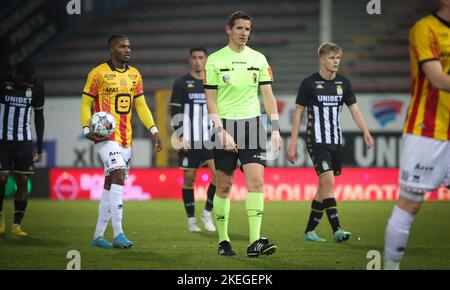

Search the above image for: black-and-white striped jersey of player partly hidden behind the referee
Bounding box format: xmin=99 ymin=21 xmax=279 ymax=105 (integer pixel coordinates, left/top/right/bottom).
xmin=170 ymin=74 xmax=211 ymax=149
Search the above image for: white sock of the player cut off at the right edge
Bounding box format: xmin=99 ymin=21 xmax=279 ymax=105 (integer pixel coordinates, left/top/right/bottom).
xmin=384 ymin=206 xmax=414 ymax=262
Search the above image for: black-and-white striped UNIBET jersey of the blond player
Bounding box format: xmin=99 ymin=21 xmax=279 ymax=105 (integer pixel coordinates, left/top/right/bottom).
xmin=295 ymin=73 xmax=356 ymax=145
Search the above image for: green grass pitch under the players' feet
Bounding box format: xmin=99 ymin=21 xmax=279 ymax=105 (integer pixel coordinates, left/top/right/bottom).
xmin=0 ymin=199 xmax=450 ymax=270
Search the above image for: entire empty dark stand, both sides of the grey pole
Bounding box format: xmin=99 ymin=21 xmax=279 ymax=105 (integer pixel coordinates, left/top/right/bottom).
xmin=35 ymin=0 xmax=432 ymax=96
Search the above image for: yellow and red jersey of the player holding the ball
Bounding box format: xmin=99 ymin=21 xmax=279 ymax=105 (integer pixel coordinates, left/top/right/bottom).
xmin=83 ymin=62 xmax=144 ymax=147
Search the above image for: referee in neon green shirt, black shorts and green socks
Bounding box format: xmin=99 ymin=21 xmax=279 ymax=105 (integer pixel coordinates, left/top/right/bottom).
xmin=204 ymin=11 xmax=281 ymax=257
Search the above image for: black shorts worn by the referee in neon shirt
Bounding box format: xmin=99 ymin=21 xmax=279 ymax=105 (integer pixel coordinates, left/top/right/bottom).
xmin=213 ymin=117 xmax=267 ymax=172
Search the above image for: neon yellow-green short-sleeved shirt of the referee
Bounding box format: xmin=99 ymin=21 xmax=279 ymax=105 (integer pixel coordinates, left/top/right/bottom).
xmin=204 ymin=45 xmax=273 ymax=120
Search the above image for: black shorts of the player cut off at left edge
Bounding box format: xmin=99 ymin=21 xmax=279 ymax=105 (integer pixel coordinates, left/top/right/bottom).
xmin=0 ymin=141 xmax=34 ymax=174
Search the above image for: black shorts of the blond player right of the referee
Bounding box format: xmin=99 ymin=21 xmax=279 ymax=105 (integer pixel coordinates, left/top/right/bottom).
xmin=307 ymin=144 xmax=342 ymax=176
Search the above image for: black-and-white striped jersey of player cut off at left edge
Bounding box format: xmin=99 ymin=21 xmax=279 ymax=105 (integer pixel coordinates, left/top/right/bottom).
xmin=0 ymin=75 xmax=45 ymax=141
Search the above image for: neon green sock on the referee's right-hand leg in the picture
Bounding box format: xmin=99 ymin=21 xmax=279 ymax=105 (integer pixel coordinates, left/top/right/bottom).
xmin=245 ymin=192 xmax=264 ymax=244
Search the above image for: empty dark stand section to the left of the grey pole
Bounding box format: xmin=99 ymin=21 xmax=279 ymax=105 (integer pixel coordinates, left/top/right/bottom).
xmin=36 ymin=0 xmax=319 ymax=96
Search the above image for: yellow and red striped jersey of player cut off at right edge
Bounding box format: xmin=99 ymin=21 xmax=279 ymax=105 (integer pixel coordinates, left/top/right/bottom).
xmin=403 ymin=14 xmax=450 ymax=140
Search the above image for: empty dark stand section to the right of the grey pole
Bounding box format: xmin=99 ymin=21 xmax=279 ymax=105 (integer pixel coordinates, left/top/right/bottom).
xmin=334 ymin=0 xmax=434 ymax=93
